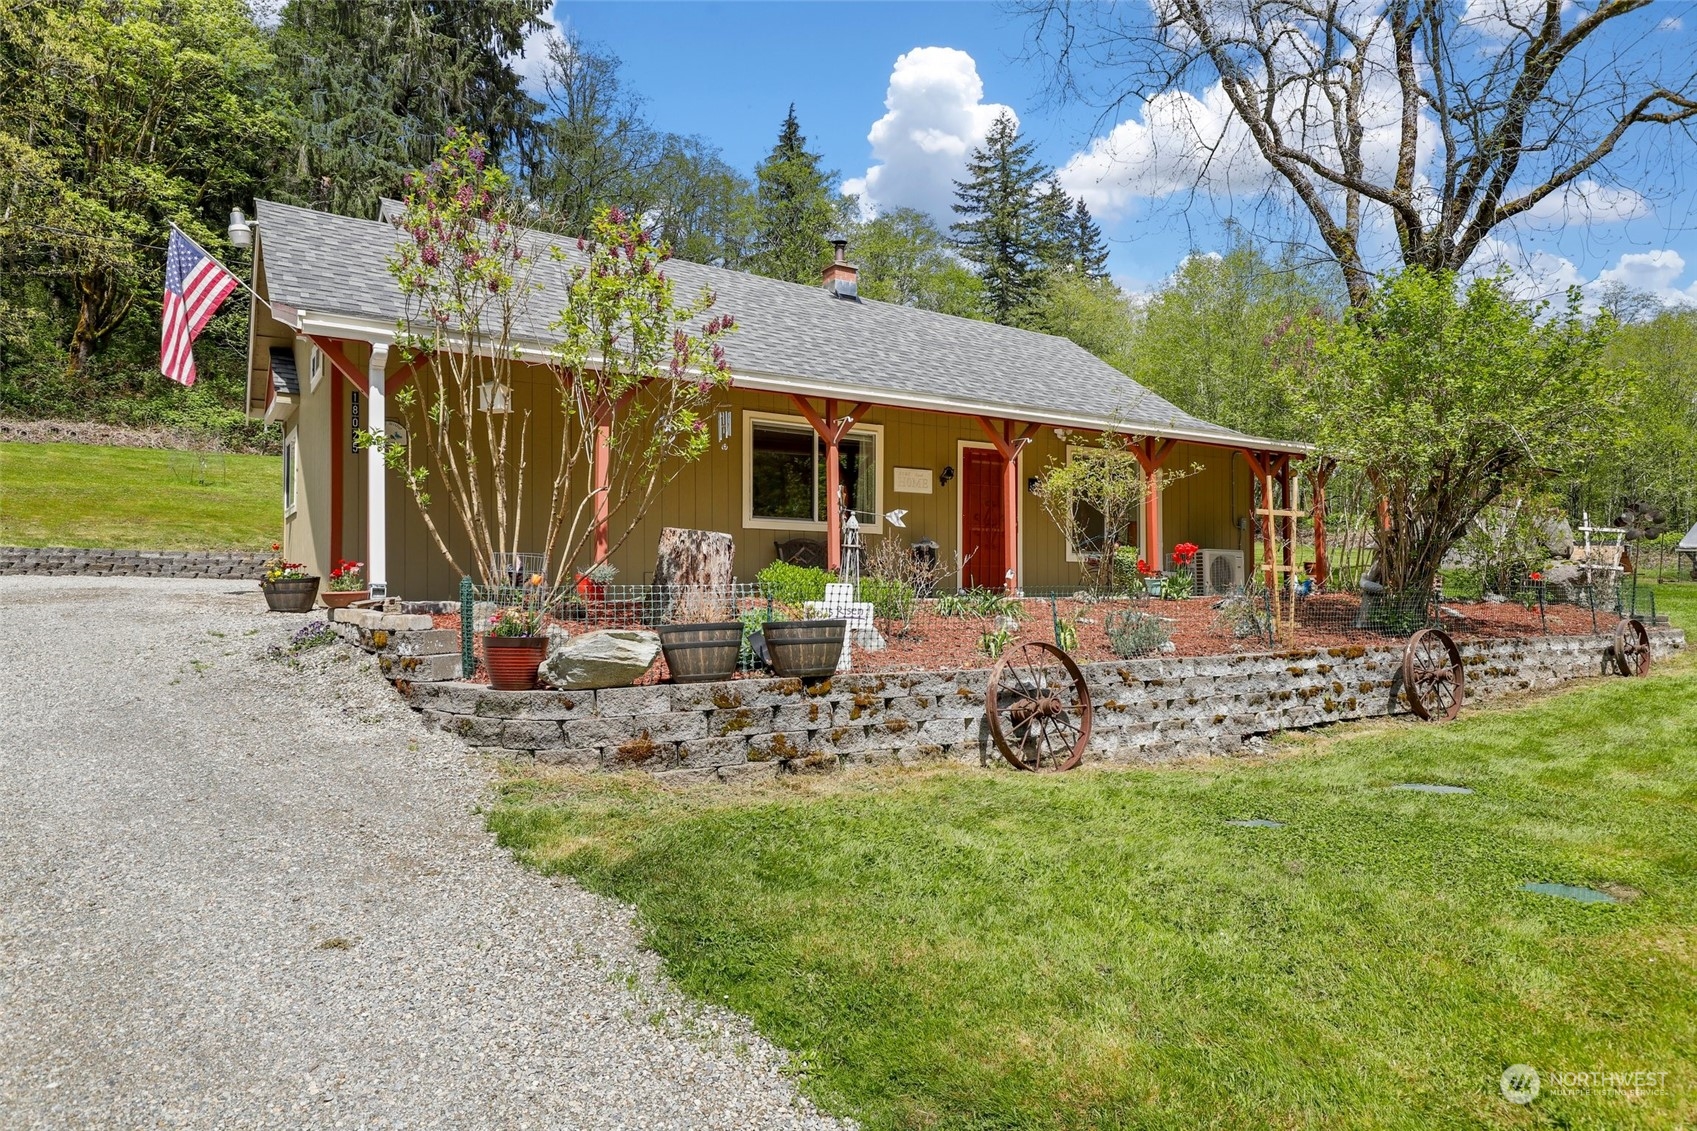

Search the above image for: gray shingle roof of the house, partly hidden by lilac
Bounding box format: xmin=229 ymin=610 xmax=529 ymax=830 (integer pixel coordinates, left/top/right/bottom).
xmin=256 ymin=200 xmax=1302 ymax=450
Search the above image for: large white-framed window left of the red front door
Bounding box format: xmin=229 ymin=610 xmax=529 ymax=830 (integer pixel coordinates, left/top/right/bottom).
xmin=742 ymin=409 xmax=884 ymax=533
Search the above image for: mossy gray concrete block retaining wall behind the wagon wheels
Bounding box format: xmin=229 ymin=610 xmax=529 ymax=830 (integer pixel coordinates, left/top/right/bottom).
xmin=397 ymin=628 xmax=1685 ymax=781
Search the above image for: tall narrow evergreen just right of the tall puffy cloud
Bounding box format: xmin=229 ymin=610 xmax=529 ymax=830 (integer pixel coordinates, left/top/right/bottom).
xmin=950 ymin=114 xmax=1049 ymax=324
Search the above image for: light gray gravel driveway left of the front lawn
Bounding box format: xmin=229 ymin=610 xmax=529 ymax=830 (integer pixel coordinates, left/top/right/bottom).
xmin=0 ymin=577 xmax=838 ymax=1131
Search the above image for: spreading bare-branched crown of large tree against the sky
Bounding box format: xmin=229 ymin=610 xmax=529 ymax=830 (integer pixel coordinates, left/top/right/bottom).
xmin=1025 ymin=0 xmax=1697 ymax=306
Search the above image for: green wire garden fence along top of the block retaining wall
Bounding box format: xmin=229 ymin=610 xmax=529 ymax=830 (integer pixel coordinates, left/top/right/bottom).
xmin=456 ymin=577 xmax=1656 ymax=681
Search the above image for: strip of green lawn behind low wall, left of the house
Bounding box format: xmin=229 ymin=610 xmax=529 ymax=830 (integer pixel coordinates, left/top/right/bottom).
xmin=0 ymin=443 xmax=282 ymax=550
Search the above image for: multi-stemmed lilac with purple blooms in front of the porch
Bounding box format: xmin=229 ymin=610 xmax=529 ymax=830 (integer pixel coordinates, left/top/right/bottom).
xmin=388 ymin=131 xmax=735 ymax=588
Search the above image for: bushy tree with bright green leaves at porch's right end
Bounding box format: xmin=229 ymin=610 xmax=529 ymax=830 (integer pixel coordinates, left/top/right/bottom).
xmin=1280 ymin=267 xmax=1629 ymax=596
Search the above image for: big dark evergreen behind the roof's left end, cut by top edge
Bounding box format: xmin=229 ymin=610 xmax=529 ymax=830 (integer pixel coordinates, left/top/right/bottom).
xmin=275 ymin=0 xmax=548 ymax=216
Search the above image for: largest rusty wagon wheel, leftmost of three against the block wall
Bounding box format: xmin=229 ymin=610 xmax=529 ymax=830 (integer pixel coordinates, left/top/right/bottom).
xmin=984 ymin=642 xmax=1091 ymax=773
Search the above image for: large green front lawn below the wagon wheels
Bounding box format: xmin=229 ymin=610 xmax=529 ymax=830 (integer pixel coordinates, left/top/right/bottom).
xmin=489 ymin=652 xmax=1697 ymax=1129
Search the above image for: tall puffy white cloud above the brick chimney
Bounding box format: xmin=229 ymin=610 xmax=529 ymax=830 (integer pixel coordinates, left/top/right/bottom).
xmin=843 ymin=48 xmax=1013 ymax=217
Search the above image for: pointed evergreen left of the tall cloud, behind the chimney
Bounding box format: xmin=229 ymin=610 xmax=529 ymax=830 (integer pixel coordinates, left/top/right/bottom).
xmin=750 ymin=104 xmax=837 ymax=284
